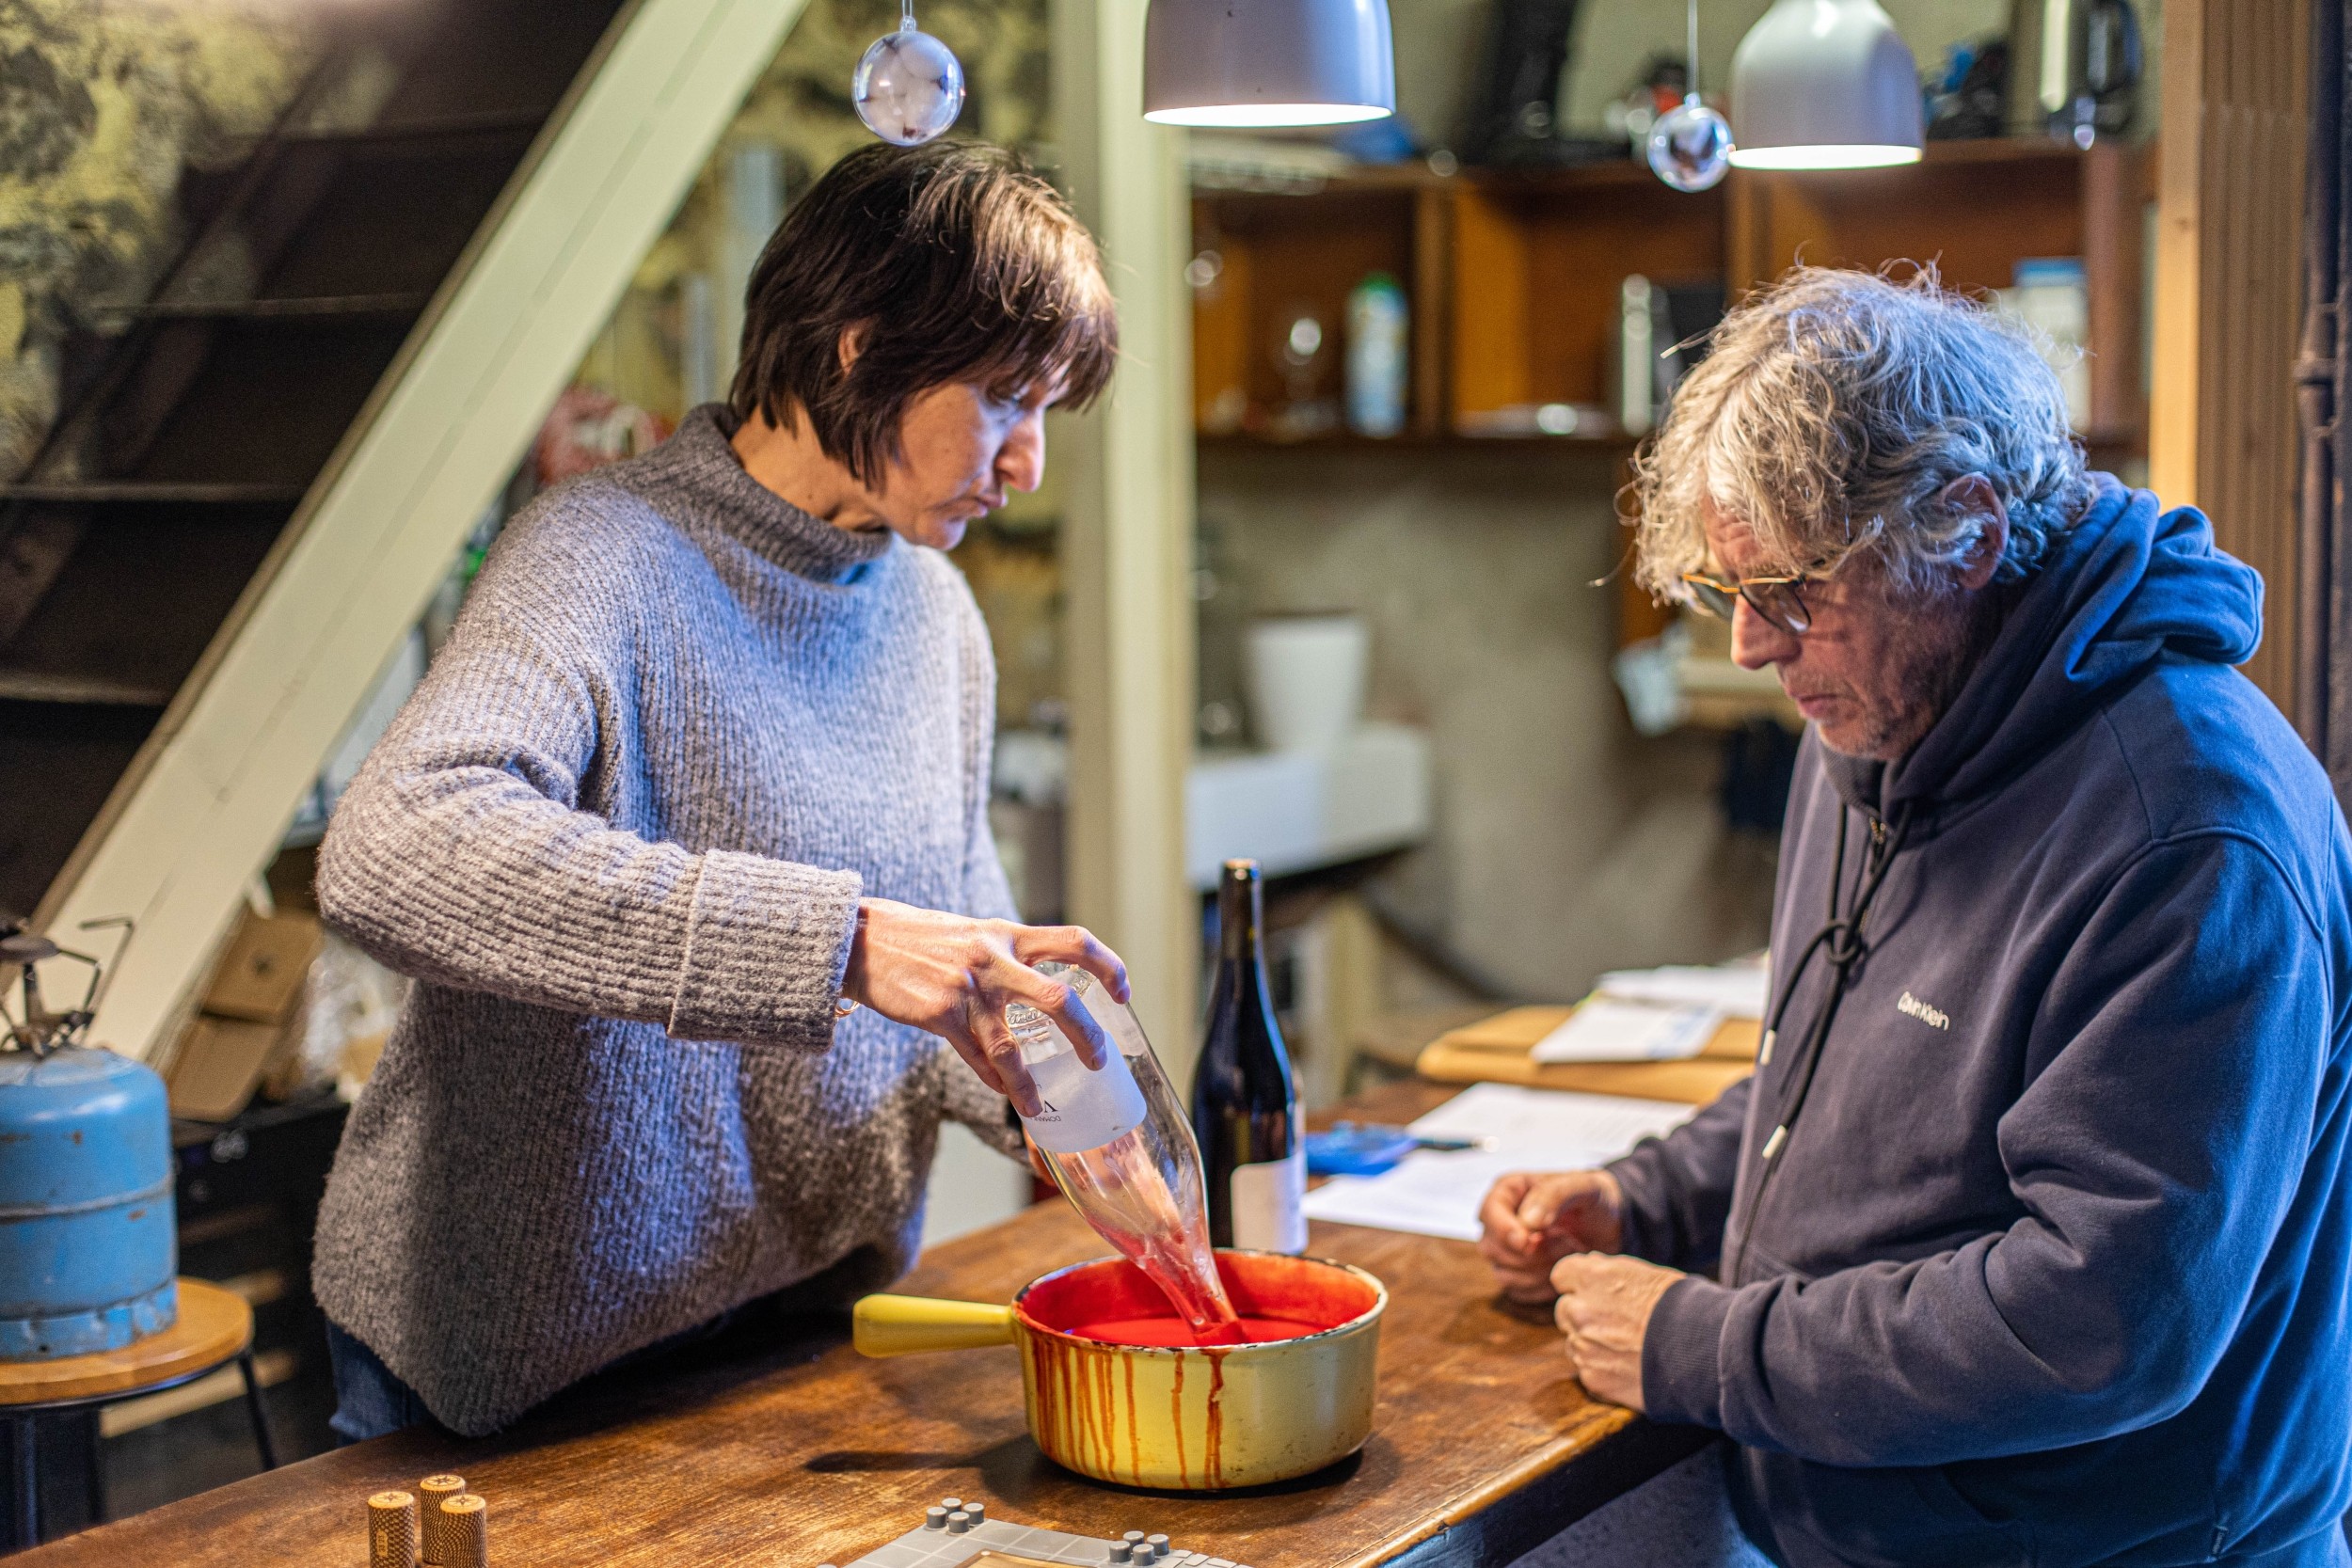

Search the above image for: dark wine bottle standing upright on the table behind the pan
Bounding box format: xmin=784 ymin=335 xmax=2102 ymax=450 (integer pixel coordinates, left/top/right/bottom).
xmin=1193 ymin=861 xmax=1308 ymax=1253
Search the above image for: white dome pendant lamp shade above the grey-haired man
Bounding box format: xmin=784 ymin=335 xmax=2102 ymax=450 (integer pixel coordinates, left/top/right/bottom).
xmin=1731 ymin=0 xmax=1922 ymax=169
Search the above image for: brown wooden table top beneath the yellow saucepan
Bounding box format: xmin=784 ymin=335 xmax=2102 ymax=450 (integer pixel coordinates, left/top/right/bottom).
xmin=19 ymin=1084 xmax=1712 ymax=1568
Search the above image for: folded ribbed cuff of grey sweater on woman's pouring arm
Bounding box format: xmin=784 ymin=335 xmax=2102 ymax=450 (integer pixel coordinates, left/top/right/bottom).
xmin=668 ymin=848 xmax=866 ymax=1051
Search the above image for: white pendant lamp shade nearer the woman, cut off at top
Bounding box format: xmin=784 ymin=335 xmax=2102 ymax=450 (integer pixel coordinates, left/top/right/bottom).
xmin=1143 ymin=0 xmax=1397 ymax=127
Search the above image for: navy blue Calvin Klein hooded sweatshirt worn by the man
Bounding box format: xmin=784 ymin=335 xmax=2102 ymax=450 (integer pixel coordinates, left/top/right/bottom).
xmin=1613 ymin=477 xmax=2352 ymax=1568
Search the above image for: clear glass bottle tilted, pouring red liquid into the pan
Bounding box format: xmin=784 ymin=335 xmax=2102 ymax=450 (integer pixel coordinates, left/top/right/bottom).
xmin=1005 ymin=964 xmax=1240 ymax=1345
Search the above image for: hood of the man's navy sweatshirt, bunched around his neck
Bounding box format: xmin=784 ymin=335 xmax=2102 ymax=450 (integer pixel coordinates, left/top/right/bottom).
xmin=1823 ymin=475 xmax=2263 ymax=814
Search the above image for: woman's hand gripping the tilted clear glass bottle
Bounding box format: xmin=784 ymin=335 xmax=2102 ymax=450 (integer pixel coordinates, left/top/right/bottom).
xmin=842 ymin=898 xmax=1127 ymax=1117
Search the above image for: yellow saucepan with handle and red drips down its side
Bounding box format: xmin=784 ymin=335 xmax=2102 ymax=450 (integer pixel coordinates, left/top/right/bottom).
xmin=856 ymin=1251 xmax=1388 ymax=1491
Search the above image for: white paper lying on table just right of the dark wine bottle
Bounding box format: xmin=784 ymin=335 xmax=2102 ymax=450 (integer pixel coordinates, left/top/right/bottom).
xmin=1306 ymin=1084 xmax=1698 ymax=1242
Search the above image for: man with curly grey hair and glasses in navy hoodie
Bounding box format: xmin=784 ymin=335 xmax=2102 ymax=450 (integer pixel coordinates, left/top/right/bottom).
xmin=1482 ymin=270 xmax=2352 ymax=1568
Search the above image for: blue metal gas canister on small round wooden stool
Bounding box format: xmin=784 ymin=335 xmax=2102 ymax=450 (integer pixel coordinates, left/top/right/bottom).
xmin=0 ymin=1049 xmax=179 ymax=1361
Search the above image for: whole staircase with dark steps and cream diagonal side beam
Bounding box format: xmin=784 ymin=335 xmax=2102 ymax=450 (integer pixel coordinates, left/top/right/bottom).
xmin=0 ymin=0 xmax=800 ymax=1051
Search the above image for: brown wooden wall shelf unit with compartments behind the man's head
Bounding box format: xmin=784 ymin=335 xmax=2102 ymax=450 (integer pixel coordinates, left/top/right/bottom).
xmin=1193 ymin=141 xmax=2154 ymax=461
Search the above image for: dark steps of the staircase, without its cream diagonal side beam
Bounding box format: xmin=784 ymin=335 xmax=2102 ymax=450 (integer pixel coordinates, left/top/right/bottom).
xmin=0 ymin=0 xmax=616 ymax=917
